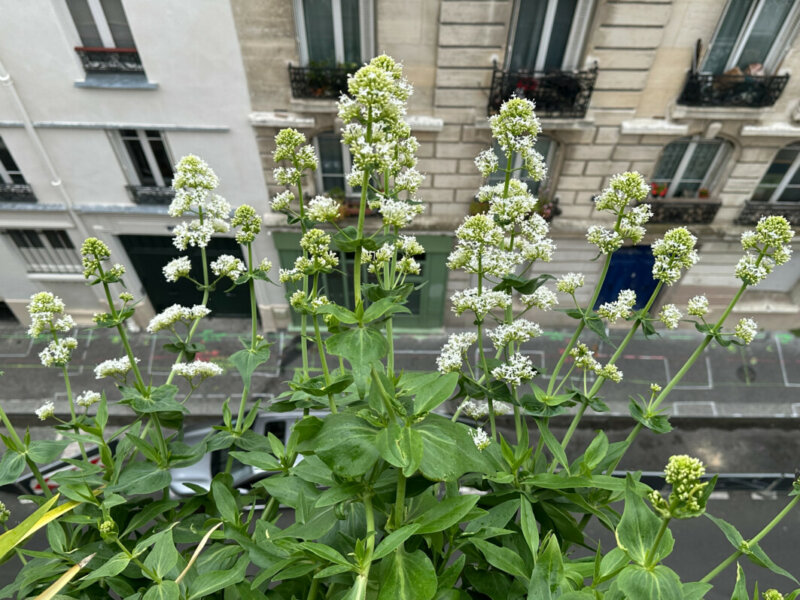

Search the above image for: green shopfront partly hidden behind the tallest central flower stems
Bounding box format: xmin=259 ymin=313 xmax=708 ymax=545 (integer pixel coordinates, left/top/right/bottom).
xmin=272 ymin=232 xmax=453 ymax=329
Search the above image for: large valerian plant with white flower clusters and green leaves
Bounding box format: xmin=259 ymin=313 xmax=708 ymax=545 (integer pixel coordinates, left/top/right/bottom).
xmin=0 ymin=56 xmax=800 ymax=600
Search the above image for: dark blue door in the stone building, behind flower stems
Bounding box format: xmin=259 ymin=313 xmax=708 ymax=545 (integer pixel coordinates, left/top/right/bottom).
xmin=594 ymin=246 xmax=658 ymax=310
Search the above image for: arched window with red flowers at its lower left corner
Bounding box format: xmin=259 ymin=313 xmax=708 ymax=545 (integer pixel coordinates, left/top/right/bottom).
xmin=651 ymin=137 xmax=731 ymax=198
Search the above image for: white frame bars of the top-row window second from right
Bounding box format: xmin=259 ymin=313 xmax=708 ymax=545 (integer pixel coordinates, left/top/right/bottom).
xmin=505 ymin=0 xmax=595 ymax=71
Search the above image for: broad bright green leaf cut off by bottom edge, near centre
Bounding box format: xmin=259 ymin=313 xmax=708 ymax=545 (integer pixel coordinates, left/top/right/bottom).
xmin=377 ymin=548 xmax=436 ymax=600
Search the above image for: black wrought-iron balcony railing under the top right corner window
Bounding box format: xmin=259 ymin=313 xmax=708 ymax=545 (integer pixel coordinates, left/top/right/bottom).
xmin=678 ymin=71 xmax=789 ymax=108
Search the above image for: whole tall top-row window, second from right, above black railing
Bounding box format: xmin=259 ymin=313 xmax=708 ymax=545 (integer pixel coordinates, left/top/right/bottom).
xmin=506 ymin=0 xmax=592 ymax=71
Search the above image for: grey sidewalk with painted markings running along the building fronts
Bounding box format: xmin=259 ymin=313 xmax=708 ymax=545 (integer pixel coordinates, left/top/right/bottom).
xmin=0 ymin=319 xmax=800 ymax=424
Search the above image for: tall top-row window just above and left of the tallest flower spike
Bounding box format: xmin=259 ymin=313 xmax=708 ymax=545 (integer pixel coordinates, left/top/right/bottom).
xmin=294 ymin=0 xmax=372 ymax=67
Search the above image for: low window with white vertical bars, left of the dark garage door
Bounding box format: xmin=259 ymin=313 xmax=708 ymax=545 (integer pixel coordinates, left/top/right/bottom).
xmin=5 ymin=229 xmax=83 ymax=273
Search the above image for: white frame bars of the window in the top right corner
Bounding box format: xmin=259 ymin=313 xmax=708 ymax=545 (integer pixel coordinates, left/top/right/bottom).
xmin=700 ymin=0 xmax=800 ymax=73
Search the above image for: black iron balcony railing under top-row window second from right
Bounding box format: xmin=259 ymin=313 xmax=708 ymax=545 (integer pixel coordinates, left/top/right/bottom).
xmin=488 ymin=63 xmax=597 ymax=119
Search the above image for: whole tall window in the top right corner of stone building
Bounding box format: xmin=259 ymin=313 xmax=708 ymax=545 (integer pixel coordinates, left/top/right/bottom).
xmin=702 ymin=0 xmax=800 ymax=75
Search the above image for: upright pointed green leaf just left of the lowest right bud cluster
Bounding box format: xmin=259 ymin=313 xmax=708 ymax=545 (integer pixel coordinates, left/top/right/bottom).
xmin=615 ymin=473 xmax=675 ymax=564
